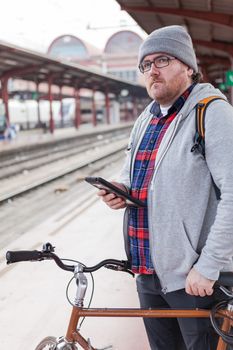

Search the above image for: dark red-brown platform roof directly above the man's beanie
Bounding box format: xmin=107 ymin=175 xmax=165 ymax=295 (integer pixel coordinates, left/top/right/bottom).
xmin=117 ymin=0 xmax=233 ymax=83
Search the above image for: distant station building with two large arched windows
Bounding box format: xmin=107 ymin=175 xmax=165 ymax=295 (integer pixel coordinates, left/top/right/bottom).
xmin=47 ymin=30 xmax=142 ymax=84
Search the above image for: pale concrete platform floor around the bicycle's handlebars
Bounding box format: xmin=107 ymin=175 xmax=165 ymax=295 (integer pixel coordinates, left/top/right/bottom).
xmin=0 ymin=196 xmax=149 ymax=350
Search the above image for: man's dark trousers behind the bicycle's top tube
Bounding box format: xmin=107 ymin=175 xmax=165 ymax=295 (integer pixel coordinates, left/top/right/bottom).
xmin=137 ymin=275 xmax=218 ymax=350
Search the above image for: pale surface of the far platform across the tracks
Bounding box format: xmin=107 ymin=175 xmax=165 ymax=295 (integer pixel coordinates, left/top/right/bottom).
xmin=0 ymin=122 xmax=133 ymax=153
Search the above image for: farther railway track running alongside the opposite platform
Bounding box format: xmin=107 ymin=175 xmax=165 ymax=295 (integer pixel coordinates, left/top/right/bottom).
xmin=0 ymin=125 xmax=130 ymax=180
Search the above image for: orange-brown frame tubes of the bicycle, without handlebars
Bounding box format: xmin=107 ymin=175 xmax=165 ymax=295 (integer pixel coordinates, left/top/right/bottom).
xmin=66 ymin=306 xmax=231 ymax=350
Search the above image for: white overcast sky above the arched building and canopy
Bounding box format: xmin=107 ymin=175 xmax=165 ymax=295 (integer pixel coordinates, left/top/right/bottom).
xmin=0 ymin=0 xmax=146 ymax=53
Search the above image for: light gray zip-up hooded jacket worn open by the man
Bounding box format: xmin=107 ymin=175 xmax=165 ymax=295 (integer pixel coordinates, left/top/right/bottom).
xmin=120 ymin=84 xmax=233 ymax=293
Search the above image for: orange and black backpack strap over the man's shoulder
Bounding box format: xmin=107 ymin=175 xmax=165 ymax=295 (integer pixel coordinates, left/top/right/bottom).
xmin=191 ymin=96 xmax=226 ymax=199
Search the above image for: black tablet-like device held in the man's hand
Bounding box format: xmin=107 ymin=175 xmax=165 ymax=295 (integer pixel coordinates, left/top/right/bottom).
xmin=85 ymin=176 xmax=146 ymax=207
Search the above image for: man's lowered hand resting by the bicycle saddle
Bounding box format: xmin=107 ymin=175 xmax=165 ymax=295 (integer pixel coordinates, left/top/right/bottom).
xmin=185 ymin=268 xmax=215 ymax=297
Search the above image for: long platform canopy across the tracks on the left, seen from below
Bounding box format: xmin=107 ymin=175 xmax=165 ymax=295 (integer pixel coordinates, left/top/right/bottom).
xmin=0 ymin=41 xmax=147 ymax=97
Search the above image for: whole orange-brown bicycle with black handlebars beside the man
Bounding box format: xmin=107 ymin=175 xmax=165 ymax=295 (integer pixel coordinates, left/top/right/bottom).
xmin=6 ymin=243 xmax=233 ymax=350
